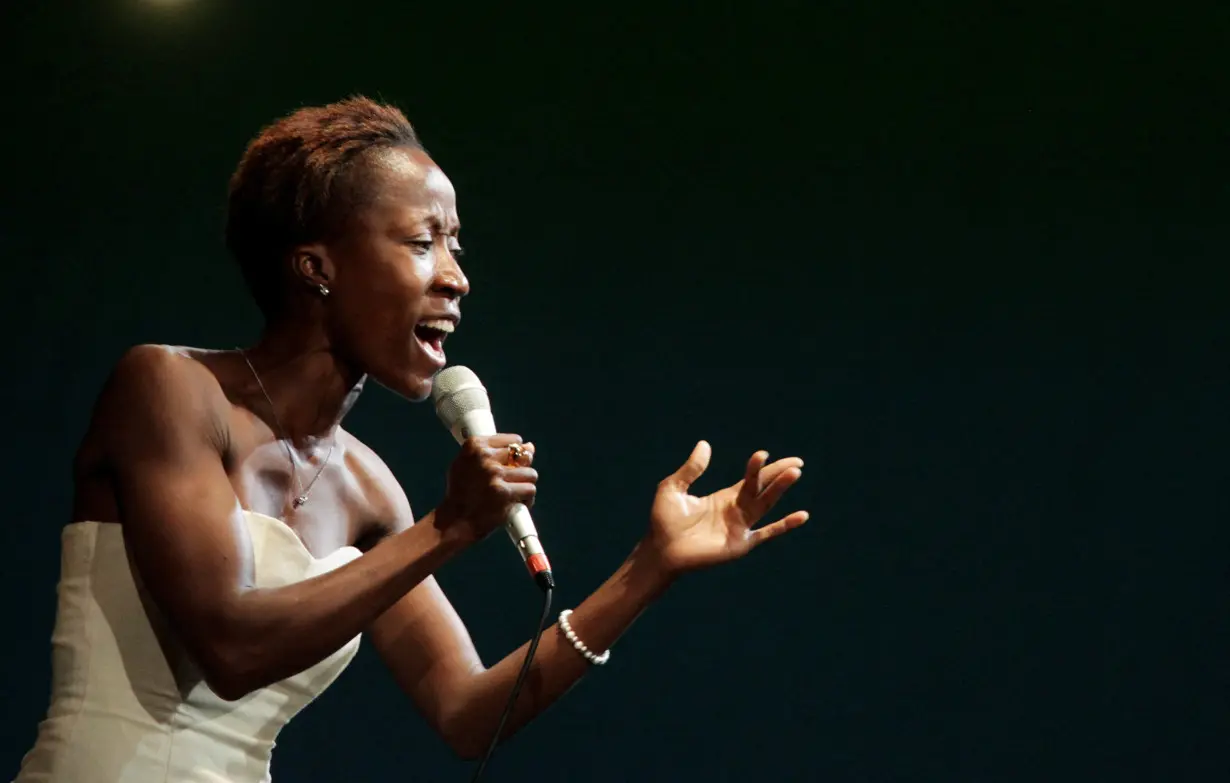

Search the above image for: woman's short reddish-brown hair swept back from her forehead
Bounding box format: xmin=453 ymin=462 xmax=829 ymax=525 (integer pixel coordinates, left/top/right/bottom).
xmin=226 ymin=96 xmax=423 ymax=318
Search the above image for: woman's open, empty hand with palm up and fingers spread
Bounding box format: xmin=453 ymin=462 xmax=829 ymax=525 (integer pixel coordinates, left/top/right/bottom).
xmin=646 ymin=440 xmax=808 ymax=575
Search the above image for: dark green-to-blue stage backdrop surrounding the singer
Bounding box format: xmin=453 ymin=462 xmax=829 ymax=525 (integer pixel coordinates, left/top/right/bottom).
xmin=0 ymin=0 xmax=1230 ymax=783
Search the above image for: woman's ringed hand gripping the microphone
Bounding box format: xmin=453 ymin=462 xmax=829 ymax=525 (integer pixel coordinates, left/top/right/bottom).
xmin=435 ymin=434 xmax=538 ymax=543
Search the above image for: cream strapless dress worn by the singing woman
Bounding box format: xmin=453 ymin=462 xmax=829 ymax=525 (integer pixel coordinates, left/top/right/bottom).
xmin=16 ymin=511 xmax=359 ymax=783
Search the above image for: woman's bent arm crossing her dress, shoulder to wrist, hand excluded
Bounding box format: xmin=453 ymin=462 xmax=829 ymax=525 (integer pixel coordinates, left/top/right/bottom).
xmin=96 ymin=345 xmax=487 ymax=699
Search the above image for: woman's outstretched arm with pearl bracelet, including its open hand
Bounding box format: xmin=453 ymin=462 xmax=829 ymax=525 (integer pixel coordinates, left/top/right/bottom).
xmin=371 ymin=444 xmax=807 ymax=758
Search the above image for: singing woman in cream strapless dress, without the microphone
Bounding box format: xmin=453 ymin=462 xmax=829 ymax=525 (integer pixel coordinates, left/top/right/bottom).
xmin=17 ymin=98 xmax=807 ymax=783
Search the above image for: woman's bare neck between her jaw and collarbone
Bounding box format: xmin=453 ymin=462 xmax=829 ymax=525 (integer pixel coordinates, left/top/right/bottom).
xmin=244 ymin=313 xmax=365 ymax=447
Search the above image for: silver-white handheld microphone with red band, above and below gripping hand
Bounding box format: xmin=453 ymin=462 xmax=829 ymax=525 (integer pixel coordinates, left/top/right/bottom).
xmin=432 ymin=366 xmax=555 ymax=590
